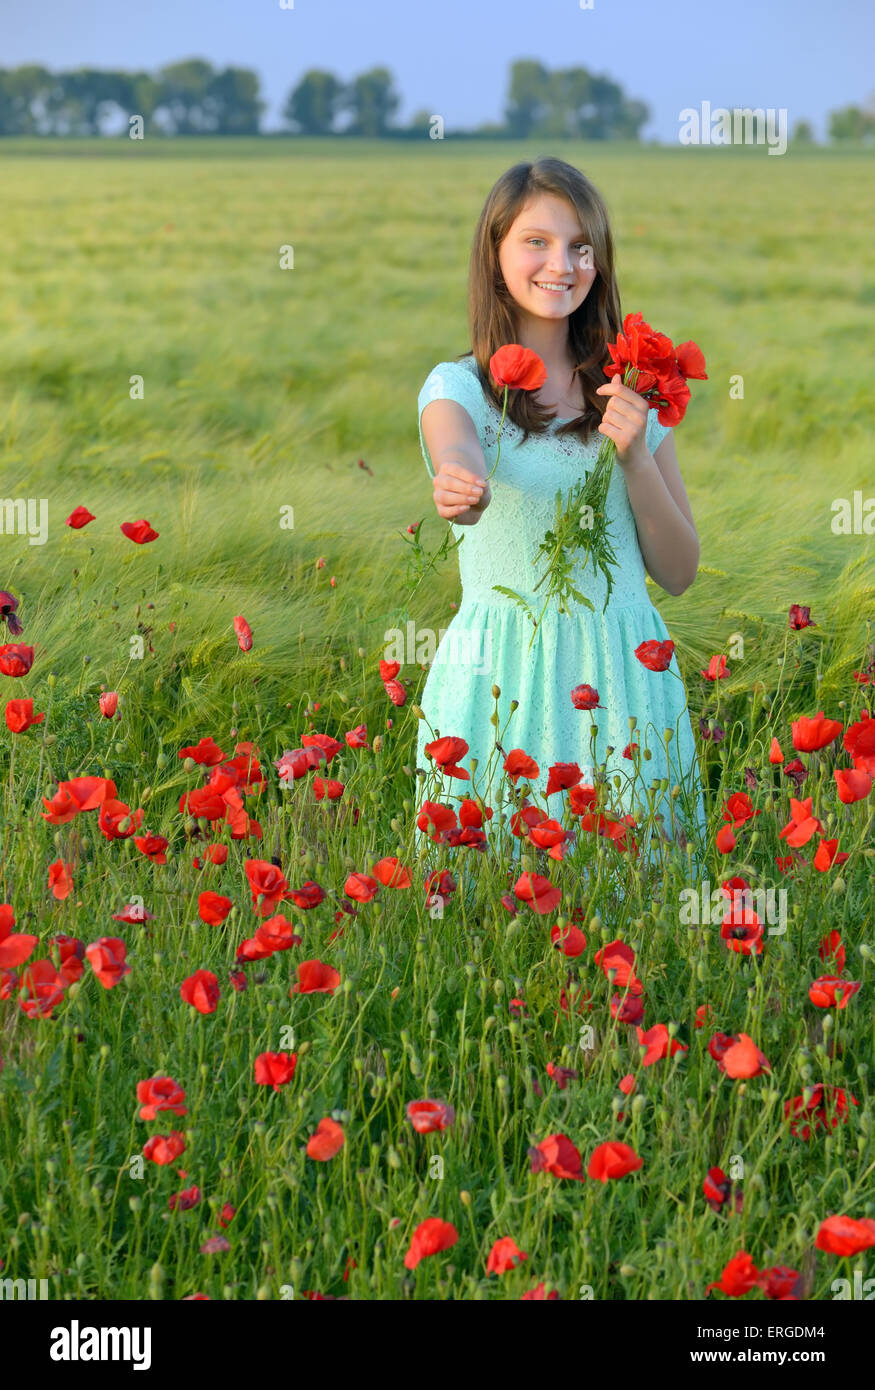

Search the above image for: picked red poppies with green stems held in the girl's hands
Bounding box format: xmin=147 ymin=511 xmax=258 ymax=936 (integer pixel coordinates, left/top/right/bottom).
xmin=488 ymin=314 xmax=707 ymax=649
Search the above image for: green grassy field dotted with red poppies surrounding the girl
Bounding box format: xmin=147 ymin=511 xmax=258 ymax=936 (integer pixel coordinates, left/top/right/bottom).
xmin=0 ymin=142 xmax=875 ymax=1301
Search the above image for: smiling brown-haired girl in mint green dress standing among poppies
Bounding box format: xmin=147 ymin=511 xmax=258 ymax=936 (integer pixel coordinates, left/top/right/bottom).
xmin=417 ymin=158 xmax=705 ymax=884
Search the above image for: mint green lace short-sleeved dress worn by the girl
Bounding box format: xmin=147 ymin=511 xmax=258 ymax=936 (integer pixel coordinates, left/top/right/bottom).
xmin=416 ymin=356 xmax=705 ymax=866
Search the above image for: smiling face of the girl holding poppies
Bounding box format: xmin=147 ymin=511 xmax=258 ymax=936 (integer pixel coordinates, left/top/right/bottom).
xmin=498 ymin=193 xmax=597 ymax=320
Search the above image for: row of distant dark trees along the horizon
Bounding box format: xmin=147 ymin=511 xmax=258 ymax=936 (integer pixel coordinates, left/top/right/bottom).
xmin=0 ymin=58 xmax=875 ymax=143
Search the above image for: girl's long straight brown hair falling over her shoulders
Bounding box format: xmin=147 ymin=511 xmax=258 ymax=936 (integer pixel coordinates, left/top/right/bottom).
xmin=456 ymin=156 xmax=622 ymax=443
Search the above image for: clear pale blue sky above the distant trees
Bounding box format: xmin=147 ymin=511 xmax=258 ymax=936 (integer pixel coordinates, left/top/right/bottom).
xmin=0 ymin=0 xmax=875 ymax=143
